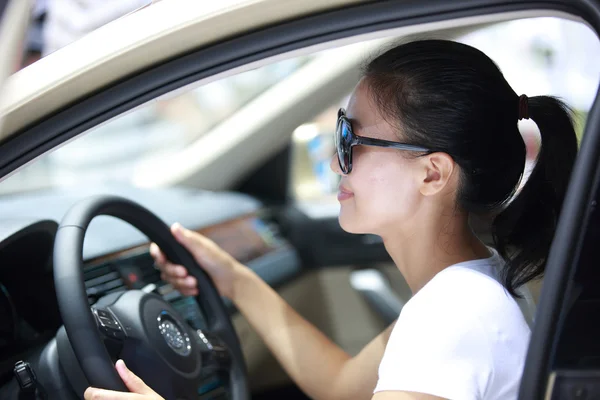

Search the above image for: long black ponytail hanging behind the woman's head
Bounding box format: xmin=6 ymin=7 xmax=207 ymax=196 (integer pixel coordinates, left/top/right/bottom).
xmin=492 ymin=96 xmax=577 ymax=296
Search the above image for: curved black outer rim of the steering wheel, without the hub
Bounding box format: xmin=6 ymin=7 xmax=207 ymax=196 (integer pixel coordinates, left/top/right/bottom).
xmin=54 ymin=196 xmax=250 ymax=400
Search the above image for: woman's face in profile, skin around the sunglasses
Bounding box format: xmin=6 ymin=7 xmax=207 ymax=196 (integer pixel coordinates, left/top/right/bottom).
xmin=331 ymin=79 xmax=425 ymax=236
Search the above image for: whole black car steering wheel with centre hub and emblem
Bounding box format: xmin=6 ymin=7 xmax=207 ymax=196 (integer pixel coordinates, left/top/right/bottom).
xmin=54 ymin=196 xmax=250 ymax=400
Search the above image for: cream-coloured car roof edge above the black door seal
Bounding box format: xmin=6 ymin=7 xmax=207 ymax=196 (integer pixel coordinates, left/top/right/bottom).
xmin=0 ymin=0 xmax=362 ymax=139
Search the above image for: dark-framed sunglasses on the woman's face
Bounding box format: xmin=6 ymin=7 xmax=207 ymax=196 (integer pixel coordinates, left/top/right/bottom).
xmin=335 ymin=108 xmax=431 ymax=175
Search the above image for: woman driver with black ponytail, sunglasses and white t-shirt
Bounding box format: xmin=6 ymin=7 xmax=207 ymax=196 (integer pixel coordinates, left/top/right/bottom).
xmin=86 ymin=40 xmax=577 ymax=400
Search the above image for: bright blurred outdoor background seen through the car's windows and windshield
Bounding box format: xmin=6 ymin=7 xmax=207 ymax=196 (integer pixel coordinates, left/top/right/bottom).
xmin=0 ymin=0 xmax=600 ymax=200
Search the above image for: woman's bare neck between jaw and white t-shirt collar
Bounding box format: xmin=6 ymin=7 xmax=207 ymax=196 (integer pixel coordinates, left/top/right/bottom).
xmin=382 ymin=209 xmax=489 ymax=295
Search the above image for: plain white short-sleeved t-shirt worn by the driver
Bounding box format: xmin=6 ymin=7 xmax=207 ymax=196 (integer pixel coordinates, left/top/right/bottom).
xmin=375 ymin=249 xmax=530 ymax=400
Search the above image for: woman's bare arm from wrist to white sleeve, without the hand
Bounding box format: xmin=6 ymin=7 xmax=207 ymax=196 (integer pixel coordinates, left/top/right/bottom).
xmin=233 ymin=269 xmax=392 ymax=400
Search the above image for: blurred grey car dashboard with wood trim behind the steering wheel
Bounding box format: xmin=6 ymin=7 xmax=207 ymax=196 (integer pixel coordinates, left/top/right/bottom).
xmin=0 ymin=187 xmax=301 ymax=395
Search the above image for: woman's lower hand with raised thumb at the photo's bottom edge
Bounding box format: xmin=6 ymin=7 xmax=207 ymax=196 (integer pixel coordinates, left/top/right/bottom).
xmin=83 ymin=360 xmax=164 ymax=400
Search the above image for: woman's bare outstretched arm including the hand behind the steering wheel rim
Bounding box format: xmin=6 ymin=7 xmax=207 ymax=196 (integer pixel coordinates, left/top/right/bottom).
xmin=151 ymin=225 xmax=391 ymax=400
